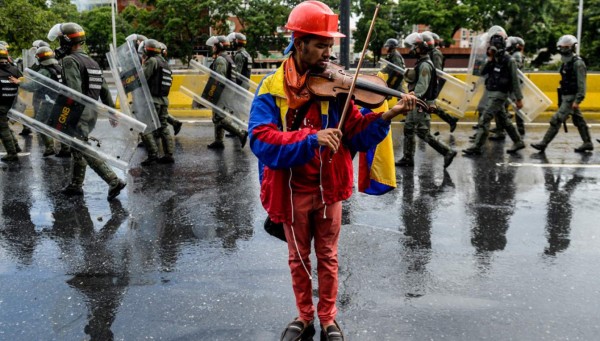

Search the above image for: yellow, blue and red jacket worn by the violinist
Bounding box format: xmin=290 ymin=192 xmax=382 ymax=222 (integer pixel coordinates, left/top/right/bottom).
xmin=248 ymin=63 xmax=390 ymax=224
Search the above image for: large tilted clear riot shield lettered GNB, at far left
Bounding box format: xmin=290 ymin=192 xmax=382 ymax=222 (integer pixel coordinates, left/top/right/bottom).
xmin=8 ymin=69 xmax=146 ymax=169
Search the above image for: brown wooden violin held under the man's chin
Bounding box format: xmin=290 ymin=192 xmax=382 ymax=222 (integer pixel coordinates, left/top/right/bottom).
xmin=307 ymin=63 xmax=435 ymax=113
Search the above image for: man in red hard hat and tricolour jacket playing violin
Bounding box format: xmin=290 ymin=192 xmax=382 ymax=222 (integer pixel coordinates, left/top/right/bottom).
xmin=248 ymin=1 xmax=416 ymax=340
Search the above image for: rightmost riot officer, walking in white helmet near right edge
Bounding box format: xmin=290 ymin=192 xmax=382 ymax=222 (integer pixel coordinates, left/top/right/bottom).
xmin=531 ymin=34 xmax=594 ymax=153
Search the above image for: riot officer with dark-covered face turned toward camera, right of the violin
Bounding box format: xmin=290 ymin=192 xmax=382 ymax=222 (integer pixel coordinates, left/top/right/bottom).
xmin=463 ymin=26 xmax=525 ymax=155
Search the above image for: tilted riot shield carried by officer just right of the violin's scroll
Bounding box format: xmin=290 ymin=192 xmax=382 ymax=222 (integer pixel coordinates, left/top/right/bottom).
xmin=379 ymin=59 xmax=467 ymax=117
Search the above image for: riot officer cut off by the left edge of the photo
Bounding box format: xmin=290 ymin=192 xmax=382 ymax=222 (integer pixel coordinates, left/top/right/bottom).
xmin=0 ymin=45 xmax=23 ymax=161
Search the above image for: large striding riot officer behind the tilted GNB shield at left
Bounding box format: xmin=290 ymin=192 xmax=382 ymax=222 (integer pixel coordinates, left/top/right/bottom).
xmin=48 ymin=23 xmax=126 ymax=200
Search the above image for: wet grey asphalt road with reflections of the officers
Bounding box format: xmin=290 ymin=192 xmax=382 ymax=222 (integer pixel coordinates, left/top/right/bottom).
xmin=0 ymin=121 xmax=600 ymax=340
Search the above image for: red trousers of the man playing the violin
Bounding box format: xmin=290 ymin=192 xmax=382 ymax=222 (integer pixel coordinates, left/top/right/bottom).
xmin=285 ymin=194 xmax=342 ymax=325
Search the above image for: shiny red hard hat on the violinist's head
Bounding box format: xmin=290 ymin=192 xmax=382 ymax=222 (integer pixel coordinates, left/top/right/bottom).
xmin=285 ymin=0 xmax=345 ymax=38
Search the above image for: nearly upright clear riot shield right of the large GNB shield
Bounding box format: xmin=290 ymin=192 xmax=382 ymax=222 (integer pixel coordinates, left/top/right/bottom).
xmin=106 ymin=41 xmax=160 ymax=133
